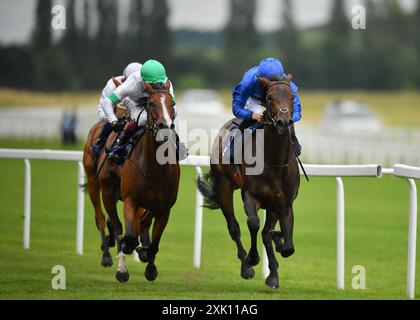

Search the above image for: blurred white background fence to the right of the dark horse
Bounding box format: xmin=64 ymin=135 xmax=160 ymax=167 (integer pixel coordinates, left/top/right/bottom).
xmin=296 ymin=125 xmax=420 ymax=166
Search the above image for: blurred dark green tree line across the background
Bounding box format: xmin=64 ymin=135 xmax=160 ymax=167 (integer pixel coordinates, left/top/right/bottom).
xmin=0 ymin=0 xmax=420 ymax=91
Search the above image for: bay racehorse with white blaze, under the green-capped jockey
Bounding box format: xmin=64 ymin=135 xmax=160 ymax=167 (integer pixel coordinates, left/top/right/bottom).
xmin=117 ymin=80 xmax=180 ymax=281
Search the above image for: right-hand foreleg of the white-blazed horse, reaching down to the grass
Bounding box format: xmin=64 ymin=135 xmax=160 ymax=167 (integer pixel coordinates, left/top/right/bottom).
xmin=144 ymin=210 xmax=170 ymax=281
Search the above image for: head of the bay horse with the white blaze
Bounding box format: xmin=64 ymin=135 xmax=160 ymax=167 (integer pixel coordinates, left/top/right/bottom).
xmin=144 ymin=80 xmax=175 ymax=134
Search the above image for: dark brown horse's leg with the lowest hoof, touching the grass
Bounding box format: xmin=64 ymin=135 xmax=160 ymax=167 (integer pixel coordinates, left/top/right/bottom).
xmin=262 ymin=210 xmax=279 ymax=289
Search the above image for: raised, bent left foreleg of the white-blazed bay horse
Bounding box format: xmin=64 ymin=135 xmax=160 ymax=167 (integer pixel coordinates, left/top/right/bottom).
xmin=121 ymin=197 xmax=144 ymax=254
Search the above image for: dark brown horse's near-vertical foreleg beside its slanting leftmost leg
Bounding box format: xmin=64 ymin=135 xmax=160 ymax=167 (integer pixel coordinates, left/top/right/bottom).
xmin=242 ymin=191 xmax=260 ymax=266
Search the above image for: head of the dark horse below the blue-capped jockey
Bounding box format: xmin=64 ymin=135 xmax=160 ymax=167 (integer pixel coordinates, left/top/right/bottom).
xmin=258 ymin=74 xmax=294 ymax=134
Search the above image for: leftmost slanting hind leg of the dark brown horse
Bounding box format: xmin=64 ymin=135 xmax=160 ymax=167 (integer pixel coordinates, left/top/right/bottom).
xmin=216 ymin=184 xmax=255 ymax=279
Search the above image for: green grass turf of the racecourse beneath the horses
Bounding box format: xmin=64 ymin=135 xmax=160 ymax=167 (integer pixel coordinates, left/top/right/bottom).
xmin=0 ymin=141 xmax=420 ymax=299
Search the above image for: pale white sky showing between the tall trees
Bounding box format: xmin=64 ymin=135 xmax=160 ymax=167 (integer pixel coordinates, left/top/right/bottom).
xmin=0 ymin=0 xmax=416 ymax=43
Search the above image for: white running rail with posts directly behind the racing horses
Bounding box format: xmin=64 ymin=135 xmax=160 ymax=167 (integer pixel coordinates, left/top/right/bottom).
xmin=0 ymin=149 xmax=420 ymax=299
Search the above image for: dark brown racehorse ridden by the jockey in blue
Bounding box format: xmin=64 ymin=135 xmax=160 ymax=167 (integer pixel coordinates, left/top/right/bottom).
xmin=197 ymin=74 xmax=300 ymax=288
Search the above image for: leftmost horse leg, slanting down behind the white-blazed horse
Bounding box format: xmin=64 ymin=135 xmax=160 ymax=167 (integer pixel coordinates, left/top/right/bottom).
xmin=87 ymin=176 xmax=112 ymax=267
